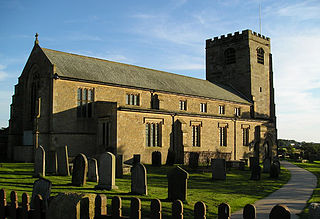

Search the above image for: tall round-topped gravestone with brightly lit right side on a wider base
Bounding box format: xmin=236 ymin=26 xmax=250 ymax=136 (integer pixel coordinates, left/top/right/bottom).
xmin=95 ymin=152 xmax=118 ymax=190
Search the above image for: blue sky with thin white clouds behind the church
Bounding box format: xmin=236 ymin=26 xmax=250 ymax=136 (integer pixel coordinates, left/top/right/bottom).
xmin=0 ymin=0 xmax=320 ymax=142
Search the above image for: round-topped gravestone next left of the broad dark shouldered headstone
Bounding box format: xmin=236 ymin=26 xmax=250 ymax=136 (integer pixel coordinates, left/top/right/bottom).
xmin=131 ymin=163 xmax=148 ymax=195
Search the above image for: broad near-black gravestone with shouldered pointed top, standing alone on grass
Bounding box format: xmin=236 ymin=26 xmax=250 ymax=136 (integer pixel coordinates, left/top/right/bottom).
xmin=167 ymin=166 xmax=189 ymax=201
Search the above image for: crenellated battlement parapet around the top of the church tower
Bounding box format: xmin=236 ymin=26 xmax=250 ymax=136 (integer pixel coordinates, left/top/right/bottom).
xmin=206 ymin=30 xmax=270 ymax=47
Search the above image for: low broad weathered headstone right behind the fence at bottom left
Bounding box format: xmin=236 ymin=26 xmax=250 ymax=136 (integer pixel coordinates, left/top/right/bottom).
xmin=46 ymin=193 xmax=96 ymax=219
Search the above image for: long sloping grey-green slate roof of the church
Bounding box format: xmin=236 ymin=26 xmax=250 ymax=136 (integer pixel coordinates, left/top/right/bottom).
xmin=41 ymin=48 xmax=250 ymax=104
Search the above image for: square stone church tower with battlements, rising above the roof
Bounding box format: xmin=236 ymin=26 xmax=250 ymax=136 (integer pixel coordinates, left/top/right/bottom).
xmin=206 ymin=30 xmax=275 ymax=122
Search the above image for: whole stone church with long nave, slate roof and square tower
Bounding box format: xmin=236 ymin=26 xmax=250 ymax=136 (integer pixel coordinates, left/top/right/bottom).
xmin=8 ymin=30 xmax=277 ymax=163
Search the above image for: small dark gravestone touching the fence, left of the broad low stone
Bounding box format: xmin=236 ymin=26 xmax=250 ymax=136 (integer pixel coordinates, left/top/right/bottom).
xmin=30 ymin=178 xmax=52 ymax=209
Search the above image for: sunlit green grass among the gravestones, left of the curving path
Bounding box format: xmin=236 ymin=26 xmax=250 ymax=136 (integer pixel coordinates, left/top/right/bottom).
xmin=0 ymin=163 xmax=290 ymax=218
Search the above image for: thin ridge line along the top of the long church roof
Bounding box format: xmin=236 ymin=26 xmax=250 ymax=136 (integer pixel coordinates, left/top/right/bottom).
xmin=41 ymin=47 xmax=210 ymax=83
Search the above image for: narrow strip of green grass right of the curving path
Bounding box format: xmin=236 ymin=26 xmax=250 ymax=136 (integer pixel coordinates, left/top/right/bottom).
xmin=293 ymin=161 xmax=320 ymax=219
